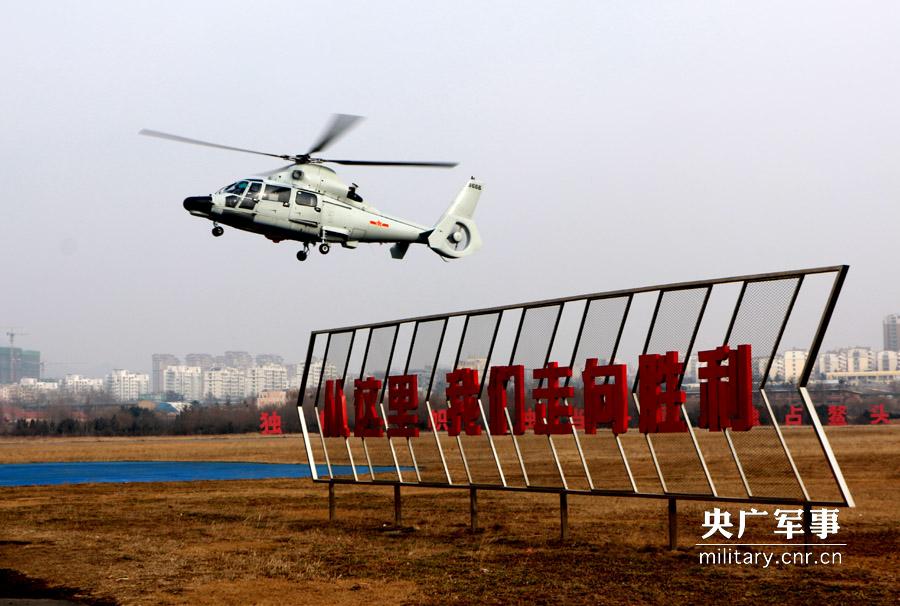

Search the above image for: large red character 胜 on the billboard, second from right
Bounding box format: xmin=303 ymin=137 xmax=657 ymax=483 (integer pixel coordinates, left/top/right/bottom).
xmin=638 ymin=351 xmax=687 ymax=433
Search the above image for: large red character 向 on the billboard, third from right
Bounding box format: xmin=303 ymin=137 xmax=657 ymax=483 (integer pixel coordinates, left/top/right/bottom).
xmin=581 ymin=358 xmax=628 ymax=435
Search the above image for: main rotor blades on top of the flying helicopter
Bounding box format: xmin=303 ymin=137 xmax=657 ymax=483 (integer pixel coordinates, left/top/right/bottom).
xmin=138 ymin=114 xmax=457 ymax=170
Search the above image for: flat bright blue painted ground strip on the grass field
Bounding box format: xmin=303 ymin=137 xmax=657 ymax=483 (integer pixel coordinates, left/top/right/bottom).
xmin=0 ymin=461 xmax=384 ymax=486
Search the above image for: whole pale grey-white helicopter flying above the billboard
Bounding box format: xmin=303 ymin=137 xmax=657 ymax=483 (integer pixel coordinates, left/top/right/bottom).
xmin=139 ymin=114 xmax=483 ymax=261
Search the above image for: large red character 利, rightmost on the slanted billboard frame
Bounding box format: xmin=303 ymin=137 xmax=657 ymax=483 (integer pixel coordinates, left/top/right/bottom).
xmin=697 ymin=345 xmax=758 ymax=431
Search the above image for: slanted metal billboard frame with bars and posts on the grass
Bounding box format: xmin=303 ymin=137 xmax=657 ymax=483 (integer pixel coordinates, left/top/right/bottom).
xmin=297 ymin=265 xmax=855 ymax=546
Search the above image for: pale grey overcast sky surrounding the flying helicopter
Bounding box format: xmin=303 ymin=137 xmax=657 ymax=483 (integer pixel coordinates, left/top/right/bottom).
xmin=0 ymin=1 xmax=900 ymax=375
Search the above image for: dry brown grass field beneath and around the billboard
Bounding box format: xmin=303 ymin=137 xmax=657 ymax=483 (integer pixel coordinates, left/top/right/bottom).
xmin=0 ymin=426 xmax=900 ymax=604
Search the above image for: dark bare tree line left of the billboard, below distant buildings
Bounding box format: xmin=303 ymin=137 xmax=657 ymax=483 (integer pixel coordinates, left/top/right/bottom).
xmin=0 ymin=402 xmax=300 ymax=436
